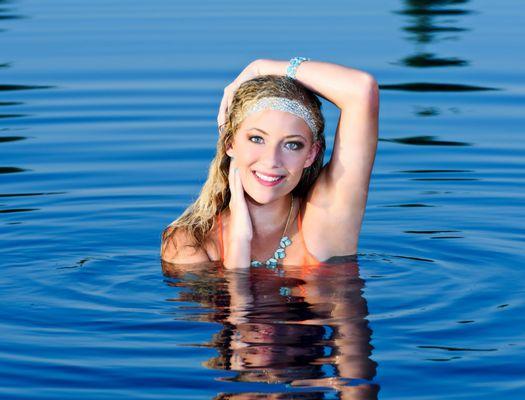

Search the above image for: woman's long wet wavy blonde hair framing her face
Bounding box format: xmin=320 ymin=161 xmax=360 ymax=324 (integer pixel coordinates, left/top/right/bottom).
xmin=162 ymin=75 xmax=326 ymax=255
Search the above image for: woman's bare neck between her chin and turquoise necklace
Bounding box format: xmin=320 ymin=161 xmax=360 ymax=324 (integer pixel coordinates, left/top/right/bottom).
xmin=246 ymin=194 xmax=297 ymax=238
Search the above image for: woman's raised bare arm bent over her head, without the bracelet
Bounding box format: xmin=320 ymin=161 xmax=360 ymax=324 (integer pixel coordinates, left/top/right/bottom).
xmin=254 ymin=59 xmax=379 ymax=216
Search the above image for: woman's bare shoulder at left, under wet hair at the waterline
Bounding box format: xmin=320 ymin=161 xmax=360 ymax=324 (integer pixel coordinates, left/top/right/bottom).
xmin=160 ymin=226 xmax=210 ymax=264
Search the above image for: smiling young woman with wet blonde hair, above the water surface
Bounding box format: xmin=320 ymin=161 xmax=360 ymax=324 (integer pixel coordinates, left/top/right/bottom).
xmin=161 ymin=57 xmax=379 ymax=269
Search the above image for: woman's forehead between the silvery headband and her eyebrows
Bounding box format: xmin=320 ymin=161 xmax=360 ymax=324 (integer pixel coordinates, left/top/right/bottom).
xmin=239 ymin=110 xmax=312 ymax=139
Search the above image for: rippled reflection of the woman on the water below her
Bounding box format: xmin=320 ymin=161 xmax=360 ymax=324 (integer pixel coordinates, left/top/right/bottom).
xmin=163 ymin=262 xmax=379 ymax=400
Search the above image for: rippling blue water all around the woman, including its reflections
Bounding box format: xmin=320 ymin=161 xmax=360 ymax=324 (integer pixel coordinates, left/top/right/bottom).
xmin=0 ymin=0 xmax=525 ymax=400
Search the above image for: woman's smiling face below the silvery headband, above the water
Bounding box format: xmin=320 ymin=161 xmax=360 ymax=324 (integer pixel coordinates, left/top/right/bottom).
xmin=227 ymin=110 xmax=318 ymax=204
